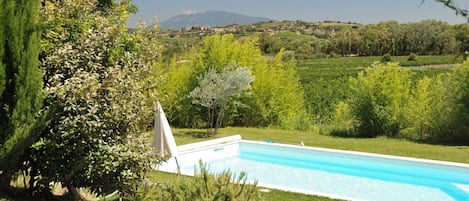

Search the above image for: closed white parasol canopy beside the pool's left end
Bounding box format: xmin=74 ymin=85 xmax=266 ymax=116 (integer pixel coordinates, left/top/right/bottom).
xmin=152 ymin=101 xmax=177 ymax=157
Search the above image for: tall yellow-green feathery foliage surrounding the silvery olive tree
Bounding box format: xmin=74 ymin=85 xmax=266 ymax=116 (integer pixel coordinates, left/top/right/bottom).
xmin=160 ymin=34 xmax=306 ymax=128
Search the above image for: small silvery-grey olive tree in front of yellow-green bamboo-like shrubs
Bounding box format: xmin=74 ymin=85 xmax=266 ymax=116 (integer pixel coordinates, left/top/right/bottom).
xmin=189 ymin=67 xmax=254 ymax=135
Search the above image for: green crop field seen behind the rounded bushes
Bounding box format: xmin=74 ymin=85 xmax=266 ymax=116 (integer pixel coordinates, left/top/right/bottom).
xmin=297 ymin=55 xmax=463 ymax=124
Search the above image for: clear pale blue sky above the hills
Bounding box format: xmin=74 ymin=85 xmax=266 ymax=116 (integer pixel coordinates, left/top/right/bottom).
xmin=129 ymin=0 xmax=469 ymax=26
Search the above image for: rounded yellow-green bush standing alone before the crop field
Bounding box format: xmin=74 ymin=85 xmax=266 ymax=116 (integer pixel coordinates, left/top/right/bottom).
xmin=347 ymin=63 xmax=411 ymax=137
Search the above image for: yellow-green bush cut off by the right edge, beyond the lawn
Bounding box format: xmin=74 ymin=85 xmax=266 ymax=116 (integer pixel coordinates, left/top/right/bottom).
xmin=403 ymin=62 xmax=469 ymax=145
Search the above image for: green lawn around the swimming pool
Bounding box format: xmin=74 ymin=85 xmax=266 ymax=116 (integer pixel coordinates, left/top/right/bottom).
xmin=146 ymin=128 xmax=469 ymax=201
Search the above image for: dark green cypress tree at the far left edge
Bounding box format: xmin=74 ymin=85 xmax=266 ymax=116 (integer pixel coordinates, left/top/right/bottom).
xmin=0 ymin=0 xmax=44 ymax=188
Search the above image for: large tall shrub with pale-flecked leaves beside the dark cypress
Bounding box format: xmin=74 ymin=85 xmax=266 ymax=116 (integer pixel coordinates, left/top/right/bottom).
xmin=28 ymin=0 xmax=159 ymax=193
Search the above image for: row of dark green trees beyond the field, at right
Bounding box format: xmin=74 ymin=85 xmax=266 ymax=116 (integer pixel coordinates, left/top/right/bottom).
xmin=259 ymin=20 xmax=469 ymax=58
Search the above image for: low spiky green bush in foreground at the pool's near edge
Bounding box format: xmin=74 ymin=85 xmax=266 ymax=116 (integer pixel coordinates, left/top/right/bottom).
xmin=139 ymin=162 xmax=260 ymax=201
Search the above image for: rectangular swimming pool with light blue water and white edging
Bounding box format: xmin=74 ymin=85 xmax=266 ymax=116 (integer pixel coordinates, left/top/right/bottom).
xmin=160 ymin=136 xmax=469 ymax=201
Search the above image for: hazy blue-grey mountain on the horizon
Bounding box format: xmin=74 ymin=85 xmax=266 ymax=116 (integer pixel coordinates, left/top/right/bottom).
xmin=160 ymin=11 xmax=275 ymax=29
